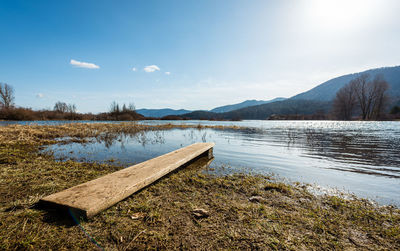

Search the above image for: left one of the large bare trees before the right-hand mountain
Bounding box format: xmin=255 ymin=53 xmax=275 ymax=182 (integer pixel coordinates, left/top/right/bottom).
xmin=333 ymin=84 xmax=357 ymax=120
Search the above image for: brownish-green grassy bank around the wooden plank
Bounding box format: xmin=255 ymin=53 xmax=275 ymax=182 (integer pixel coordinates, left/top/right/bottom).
xmin=0 ymin=124 xmax=400 ymax=250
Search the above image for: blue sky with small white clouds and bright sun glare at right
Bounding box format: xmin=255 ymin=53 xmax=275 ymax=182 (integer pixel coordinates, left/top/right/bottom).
xmin=0 ymin=0 xmax=400 ymax=113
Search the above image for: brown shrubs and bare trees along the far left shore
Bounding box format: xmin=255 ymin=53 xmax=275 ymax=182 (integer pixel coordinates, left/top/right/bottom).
xmin=0 ymin=83 xmax=145 ymax=121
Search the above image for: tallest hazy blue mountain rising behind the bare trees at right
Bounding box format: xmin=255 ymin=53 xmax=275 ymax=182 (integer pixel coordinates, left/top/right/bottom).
xmin=290 ymin=66 xmax=400 ymax=101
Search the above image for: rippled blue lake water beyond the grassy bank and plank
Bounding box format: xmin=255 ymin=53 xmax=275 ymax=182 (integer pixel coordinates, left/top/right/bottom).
xmin=0 ymin=121 xmax=400 ymax=206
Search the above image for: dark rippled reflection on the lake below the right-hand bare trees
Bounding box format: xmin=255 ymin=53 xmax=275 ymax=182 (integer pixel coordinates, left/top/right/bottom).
xmin=282 ymin=129 xmax=400 ymax=178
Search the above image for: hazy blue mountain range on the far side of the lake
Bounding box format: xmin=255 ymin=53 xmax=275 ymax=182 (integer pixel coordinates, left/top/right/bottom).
xmin=137 ymin=66 xmax=400 ymax=120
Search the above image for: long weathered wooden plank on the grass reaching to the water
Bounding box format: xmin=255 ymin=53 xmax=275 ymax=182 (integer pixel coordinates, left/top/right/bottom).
xmin=41 ymin=143 xmax=215 ymax=218
